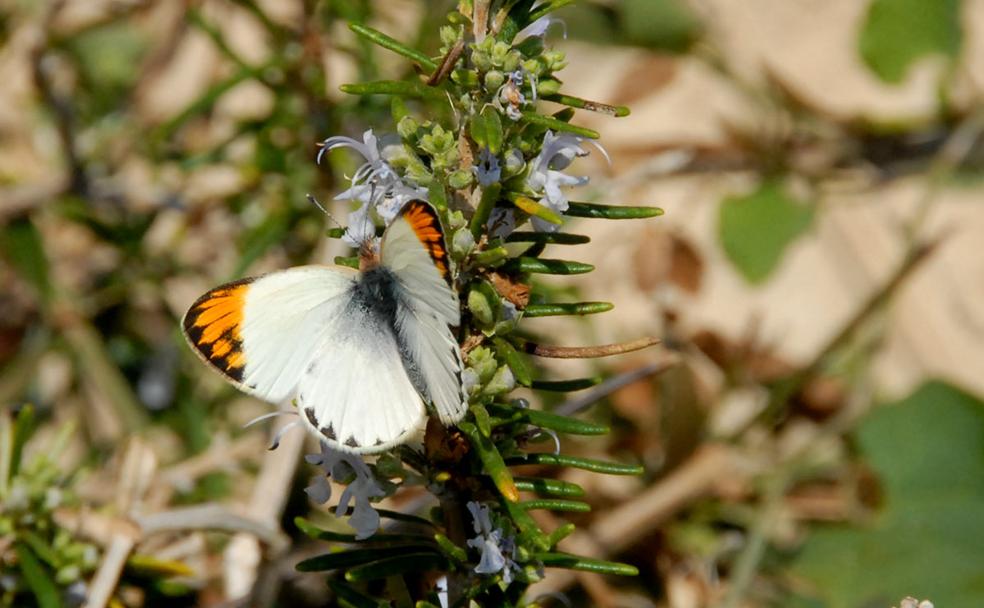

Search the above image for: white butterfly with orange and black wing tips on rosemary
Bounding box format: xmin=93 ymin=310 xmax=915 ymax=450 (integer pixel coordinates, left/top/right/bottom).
xmin=183 ymin=200 xmax=468 ymax=453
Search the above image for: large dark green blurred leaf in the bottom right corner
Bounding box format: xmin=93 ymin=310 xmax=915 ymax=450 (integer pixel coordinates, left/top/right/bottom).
xmin=793 ymin=382 xmax=984 ymax=608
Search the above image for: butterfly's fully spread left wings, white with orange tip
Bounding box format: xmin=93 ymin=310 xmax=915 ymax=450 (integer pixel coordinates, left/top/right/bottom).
xmin=184 ymin=266 xmax=426 ymax=452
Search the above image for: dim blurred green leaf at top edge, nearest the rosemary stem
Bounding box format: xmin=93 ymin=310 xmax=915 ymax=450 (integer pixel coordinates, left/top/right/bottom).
xmin=620 ymin=0 xmax=701 ymax=53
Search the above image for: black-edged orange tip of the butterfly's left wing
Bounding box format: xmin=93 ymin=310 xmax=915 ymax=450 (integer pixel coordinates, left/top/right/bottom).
xmin=184 ymin=279 xmax=252 ymax=382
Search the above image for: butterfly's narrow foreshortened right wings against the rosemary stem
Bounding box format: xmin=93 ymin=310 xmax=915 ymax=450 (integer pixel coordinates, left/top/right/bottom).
xmin=381 ymin=201 xmax=468 ymax=424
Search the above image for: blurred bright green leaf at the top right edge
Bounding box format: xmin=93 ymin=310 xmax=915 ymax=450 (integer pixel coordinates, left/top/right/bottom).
xmin=858 ymin=0 xmax=963 ymax=83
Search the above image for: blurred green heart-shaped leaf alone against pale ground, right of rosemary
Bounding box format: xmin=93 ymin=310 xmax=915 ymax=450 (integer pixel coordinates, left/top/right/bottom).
xmin=718 ymin=179 xmax=814 ymax=283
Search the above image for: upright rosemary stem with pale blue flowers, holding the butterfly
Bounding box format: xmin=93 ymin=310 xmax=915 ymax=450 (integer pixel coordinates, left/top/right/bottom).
xmin=296 ymin=0 xmax=661 ymax=607
